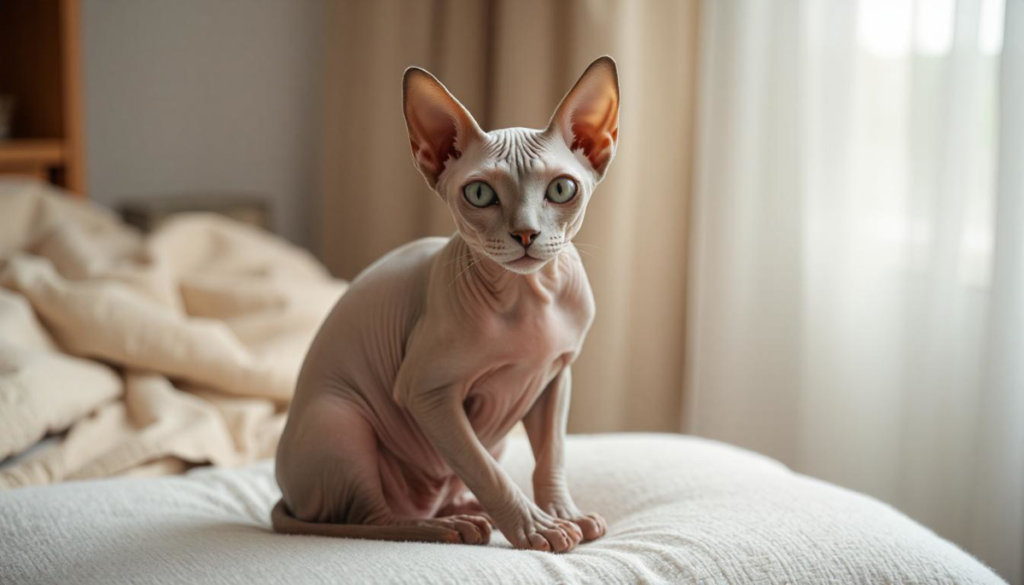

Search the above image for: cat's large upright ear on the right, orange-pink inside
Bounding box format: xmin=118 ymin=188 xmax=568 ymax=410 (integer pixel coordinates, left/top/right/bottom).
xmin=548 ymin=55 xmax=618 ymax=179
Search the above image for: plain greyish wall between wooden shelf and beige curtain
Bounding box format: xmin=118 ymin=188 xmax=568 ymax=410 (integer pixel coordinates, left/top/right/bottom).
xmin=82 ymin=0 xmax=327 ymax=244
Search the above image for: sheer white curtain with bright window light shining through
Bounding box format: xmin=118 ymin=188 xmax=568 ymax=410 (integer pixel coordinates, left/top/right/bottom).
xmin=685 ymin=0 xmax=1024 ymax=582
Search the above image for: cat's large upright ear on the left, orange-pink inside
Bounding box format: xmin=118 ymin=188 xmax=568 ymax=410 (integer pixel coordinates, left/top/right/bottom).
xmin=402 ymin=67 xmax=483 ymax=189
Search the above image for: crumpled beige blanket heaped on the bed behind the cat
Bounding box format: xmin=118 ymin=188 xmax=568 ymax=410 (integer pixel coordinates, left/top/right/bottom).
xmin=0 ymin=179 xmax=346 ymax=489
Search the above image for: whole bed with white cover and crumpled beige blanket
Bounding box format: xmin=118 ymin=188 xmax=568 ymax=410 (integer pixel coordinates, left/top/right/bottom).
xmin=0 ymin=182 xmax=1001 ymax=584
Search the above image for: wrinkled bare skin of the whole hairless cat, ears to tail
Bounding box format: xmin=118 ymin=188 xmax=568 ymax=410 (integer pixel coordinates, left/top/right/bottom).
xmin=272 ymin=57 xmax=618 ymax=552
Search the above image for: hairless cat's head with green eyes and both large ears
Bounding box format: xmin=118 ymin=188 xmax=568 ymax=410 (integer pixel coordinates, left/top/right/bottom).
xmin=403 ymin=56 xmax=618 ymax=274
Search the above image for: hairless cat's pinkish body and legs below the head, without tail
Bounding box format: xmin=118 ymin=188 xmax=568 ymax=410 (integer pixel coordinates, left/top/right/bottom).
xmin=278 ymin=237 xmax=603 ymax=550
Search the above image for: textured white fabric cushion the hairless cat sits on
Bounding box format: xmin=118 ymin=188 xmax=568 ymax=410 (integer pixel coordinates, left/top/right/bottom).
xmin=0 ymin=434 xmax=1001 ymax=584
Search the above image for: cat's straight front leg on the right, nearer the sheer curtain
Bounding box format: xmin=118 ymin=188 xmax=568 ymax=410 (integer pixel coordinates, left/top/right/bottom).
xmin=522 ymin=366 xmax=607 ymax=541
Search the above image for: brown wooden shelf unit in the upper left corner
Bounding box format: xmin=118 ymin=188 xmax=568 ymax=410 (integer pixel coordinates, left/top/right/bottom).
xmin=0 ymin=0 xmax=86 ymax=197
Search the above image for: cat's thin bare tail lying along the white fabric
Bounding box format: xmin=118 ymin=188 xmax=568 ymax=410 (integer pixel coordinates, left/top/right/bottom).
xmin=270 ymin=500 xmax=462 ymax=543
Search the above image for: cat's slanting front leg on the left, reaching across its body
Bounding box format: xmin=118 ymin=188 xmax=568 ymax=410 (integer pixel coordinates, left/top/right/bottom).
xmin=403 ymin=386 xmax=584 ymax=552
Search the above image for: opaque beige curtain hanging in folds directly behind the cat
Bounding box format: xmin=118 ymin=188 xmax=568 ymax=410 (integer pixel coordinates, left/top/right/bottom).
xmin=317 ymin=0 xmax=697 ymax=432
